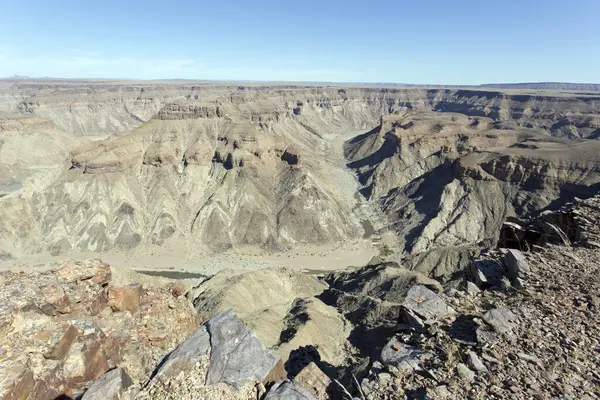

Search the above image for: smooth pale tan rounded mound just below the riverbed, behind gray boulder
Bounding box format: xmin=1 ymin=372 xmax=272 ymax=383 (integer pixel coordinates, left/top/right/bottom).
xmin=188 ymin=268 xmax=350 ymax=365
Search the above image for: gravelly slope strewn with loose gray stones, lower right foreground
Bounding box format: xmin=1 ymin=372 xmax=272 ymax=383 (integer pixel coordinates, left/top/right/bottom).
xmin=354 ymin=198 xmax=600 ymax=399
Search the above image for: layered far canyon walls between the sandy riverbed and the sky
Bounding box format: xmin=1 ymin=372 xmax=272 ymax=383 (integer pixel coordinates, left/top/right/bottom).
xmin=0 ymin=80 xmax=600 ymax=268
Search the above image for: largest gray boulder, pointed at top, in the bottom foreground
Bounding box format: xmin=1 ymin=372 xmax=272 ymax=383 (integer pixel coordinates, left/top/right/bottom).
xmin=206 ymin=310 xmax=285 ymax=389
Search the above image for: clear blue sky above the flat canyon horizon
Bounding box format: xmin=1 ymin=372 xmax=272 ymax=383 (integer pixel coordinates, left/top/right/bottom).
xmin=0 ymin=0 xmax=600 ymax=84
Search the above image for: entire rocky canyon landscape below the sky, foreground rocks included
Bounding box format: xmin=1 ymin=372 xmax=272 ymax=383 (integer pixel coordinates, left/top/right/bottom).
xmin=0 ymin=79 xmax=600 ymax=400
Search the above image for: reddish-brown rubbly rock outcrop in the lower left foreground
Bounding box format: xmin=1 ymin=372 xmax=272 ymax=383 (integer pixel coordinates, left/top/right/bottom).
xmin=0 ymin=260 xmax=198 ymax=399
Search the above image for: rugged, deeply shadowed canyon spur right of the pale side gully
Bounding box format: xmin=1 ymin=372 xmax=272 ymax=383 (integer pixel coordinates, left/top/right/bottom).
xmin=345 ymin=112 xmax=600 ymax=253
